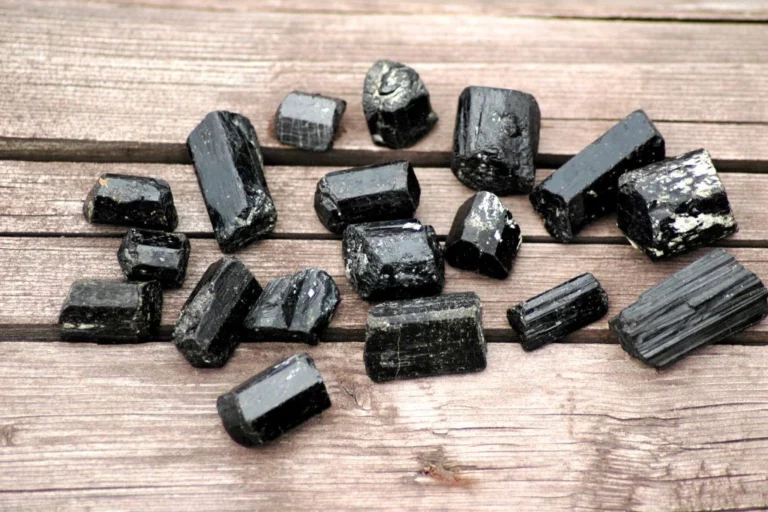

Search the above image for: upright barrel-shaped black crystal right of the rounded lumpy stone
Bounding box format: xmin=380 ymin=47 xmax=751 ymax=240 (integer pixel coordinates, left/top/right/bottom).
xmin=451 ymin=87 xmax=541 ymax=195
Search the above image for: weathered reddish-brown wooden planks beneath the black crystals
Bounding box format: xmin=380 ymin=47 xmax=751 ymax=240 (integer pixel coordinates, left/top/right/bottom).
xmin=0 ymin=0 xmax=768 ymax=511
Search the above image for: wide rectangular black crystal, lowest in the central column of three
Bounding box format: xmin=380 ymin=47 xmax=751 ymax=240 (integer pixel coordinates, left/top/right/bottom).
xmin=363 ymin=292 xmax=486 ymax=382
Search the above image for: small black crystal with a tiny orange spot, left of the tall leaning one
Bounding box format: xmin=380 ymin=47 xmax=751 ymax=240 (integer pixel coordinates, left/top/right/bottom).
xmin=83 ymin=174 xmax=179 ymax=231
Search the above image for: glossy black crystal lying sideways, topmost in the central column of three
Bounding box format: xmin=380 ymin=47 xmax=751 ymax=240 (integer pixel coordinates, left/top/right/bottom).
xmin=315 ymin=160 xmax=421 ymax=234
